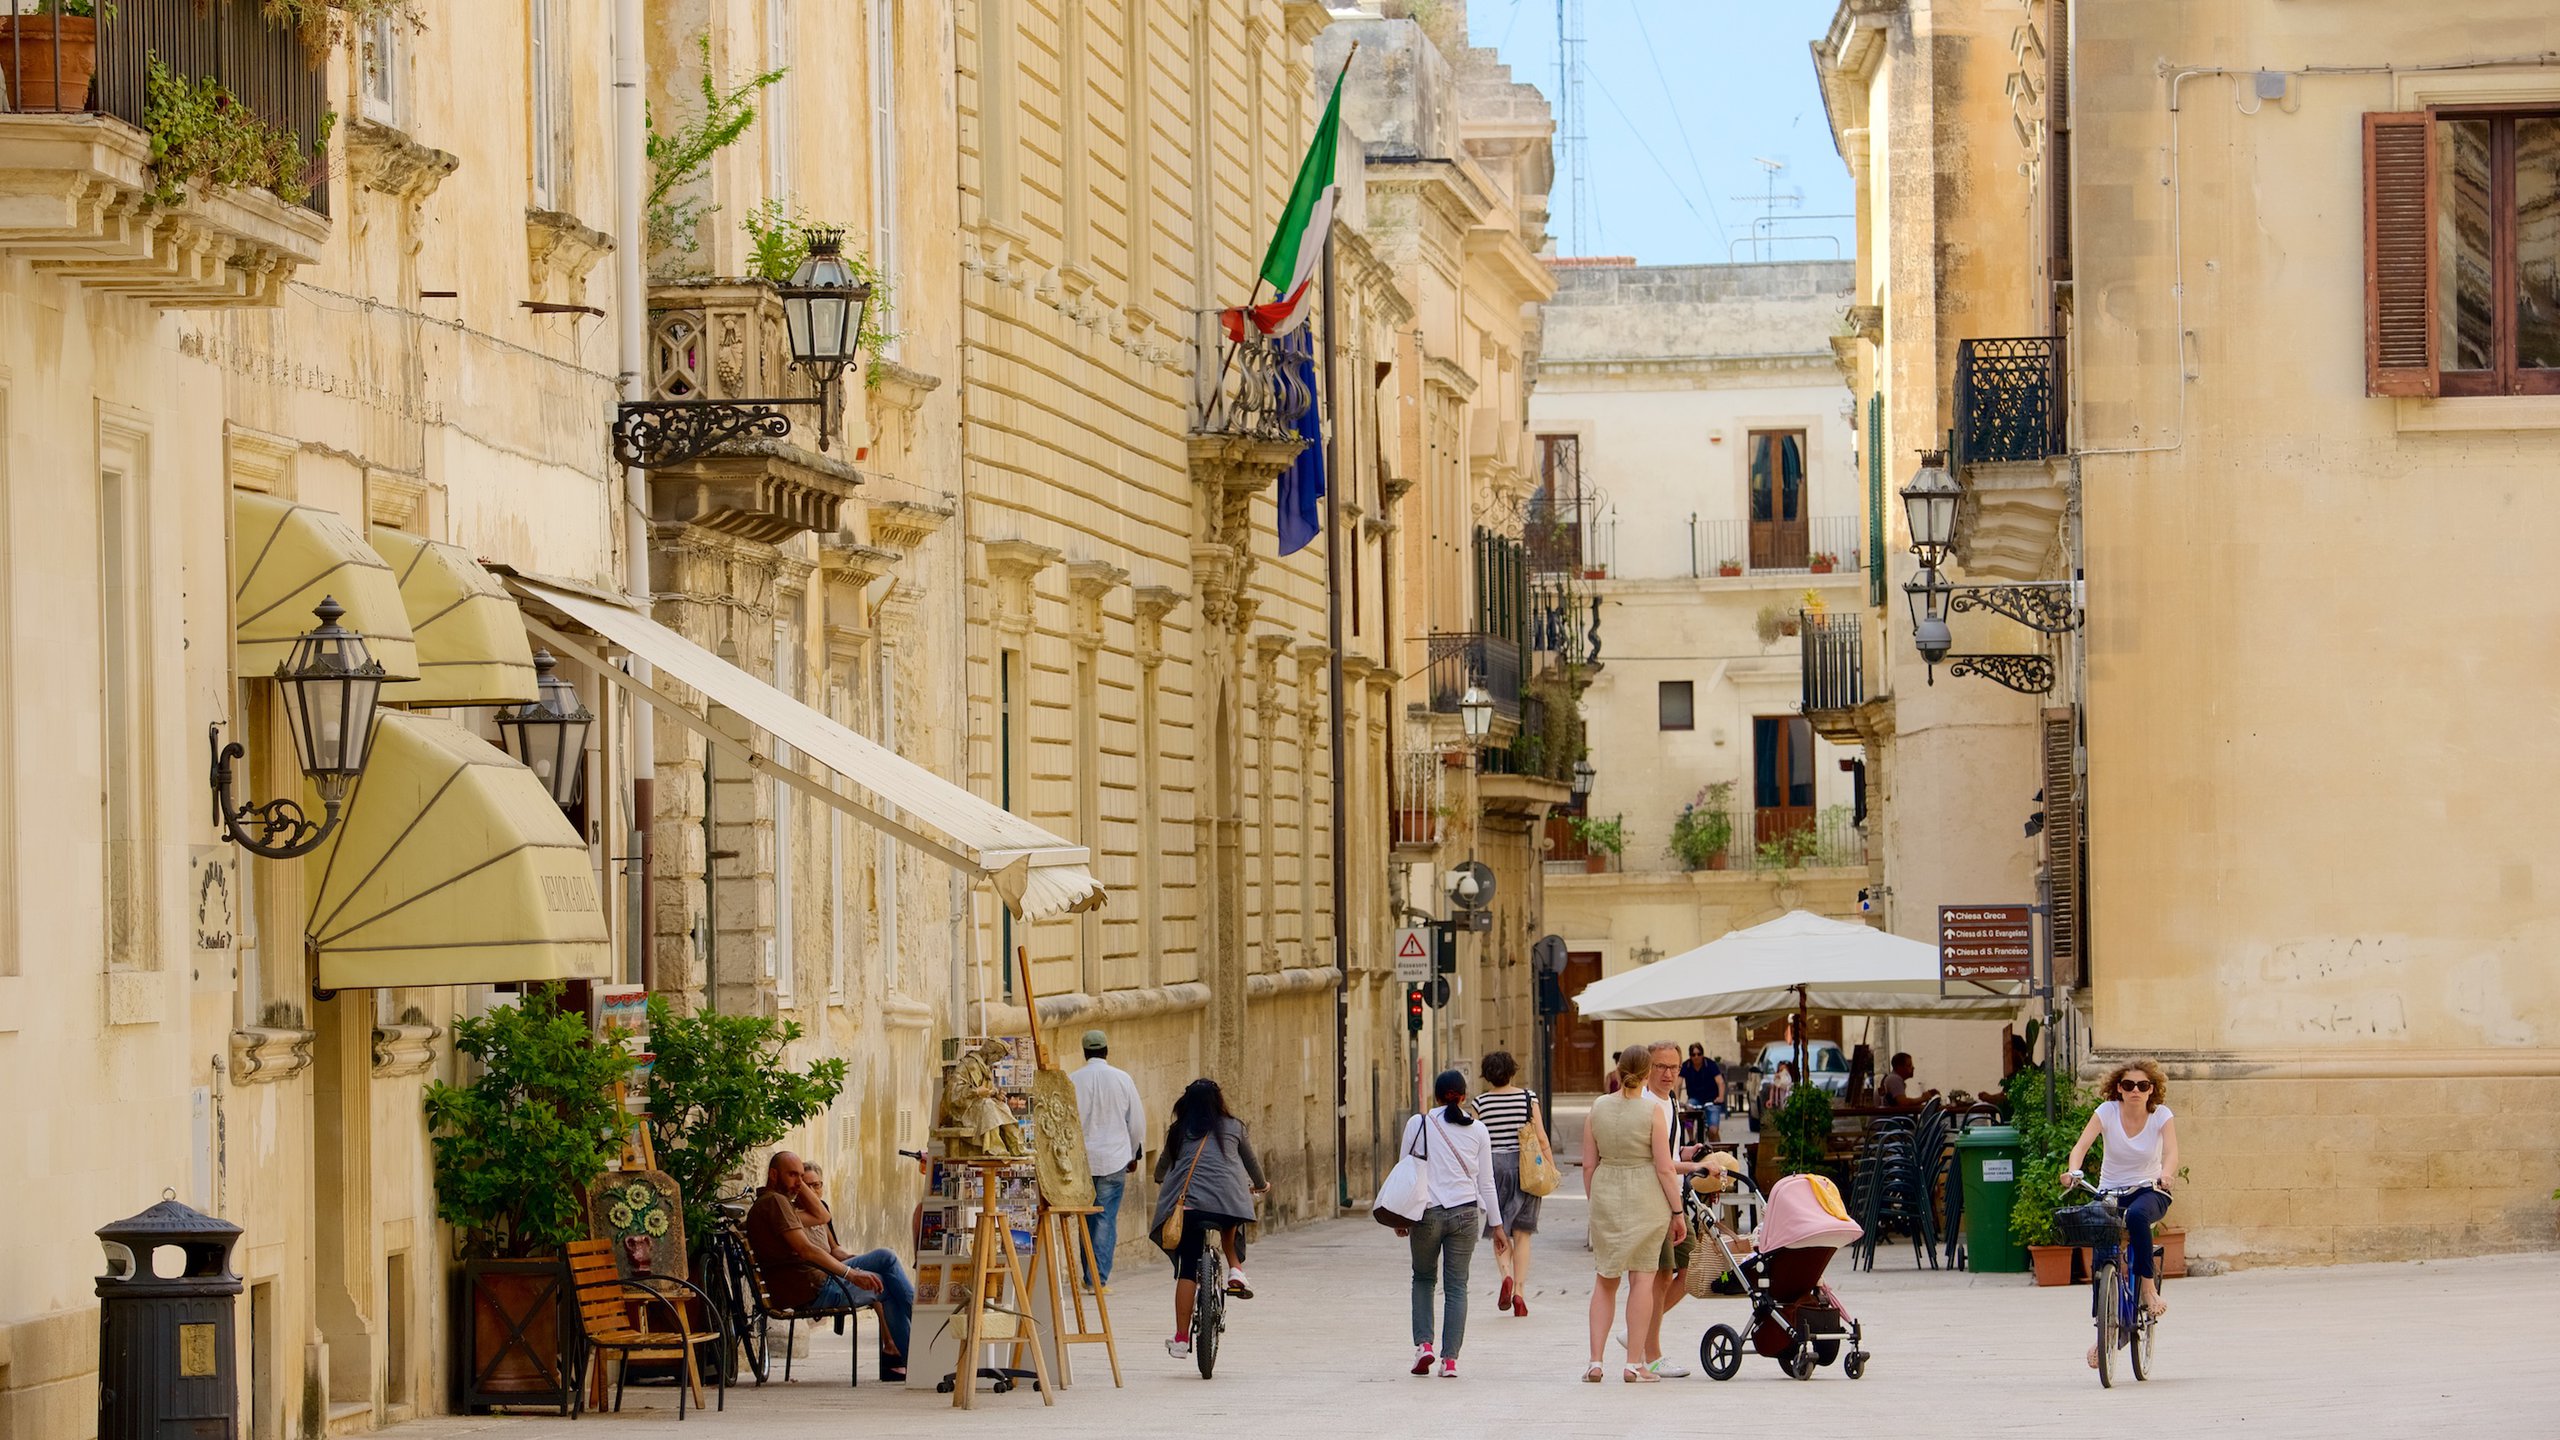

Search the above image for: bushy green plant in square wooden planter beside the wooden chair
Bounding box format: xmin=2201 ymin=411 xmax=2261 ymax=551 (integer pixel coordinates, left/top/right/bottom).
xmin=425 ymin=986 xmax=630 ymax=1409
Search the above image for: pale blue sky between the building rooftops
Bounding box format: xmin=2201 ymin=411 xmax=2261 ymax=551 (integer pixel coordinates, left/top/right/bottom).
xmin=1467 ymin=0 xmax=1851 ymax=264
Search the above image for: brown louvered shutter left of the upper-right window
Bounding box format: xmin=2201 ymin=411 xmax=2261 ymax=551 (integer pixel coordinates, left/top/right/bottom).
xmin=2365 ymin=110 xmax=2437 ymax=395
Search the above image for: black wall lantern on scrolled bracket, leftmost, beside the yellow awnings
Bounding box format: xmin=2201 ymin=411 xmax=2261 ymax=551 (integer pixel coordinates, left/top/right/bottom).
xmin=212 ymin=597 xmax=387 ymax=861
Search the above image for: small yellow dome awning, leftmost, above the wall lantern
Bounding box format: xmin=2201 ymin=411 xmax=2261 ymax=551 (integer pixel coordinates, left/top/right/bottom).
xmin=230 ymin=489 xmax=417 ymax=676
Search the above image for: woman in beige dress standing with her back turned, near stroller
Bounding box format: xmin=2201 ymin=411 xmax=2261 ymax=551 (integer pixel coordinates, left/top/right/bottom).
xmin=1582 ymin=1045 xmax=1687 ymax=1384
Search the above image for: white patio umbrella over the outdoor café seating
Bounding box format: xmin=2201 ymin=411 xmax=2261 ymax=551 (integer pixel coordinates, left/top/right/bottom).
xmin=1574 ymin=910 xmax=2020 ymax=1020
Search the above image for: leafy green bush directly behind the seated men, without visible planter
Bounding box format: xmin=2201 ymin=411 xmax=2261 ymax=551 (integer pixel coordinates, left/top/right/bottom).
xmin=648 ymin=997 xmax=845 ymax=1256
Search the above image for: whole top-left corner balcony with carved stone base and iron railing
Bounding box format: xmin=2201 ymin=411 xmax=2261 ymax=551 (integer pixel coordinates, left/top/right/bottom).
xmin=0 ymin=0 xmax=328 ymax=310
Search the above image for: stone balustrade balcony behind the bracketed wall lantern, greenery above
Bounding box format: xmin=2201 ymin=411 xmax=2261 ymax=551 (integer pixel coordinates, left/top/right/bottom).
xmin=648 ymin=279 xmax=860 ymax=543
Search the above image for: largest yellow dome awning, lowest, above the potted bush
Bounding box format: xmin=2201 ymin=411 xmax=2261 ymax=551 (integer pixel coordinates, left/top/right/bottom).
xmin=302 ymin=710 xmax=612 ymax=989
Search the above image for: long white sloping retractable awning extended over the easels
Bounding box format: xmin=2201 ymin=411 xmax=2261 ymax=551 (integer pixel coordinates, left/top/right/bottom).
xmin=507 ymin=577 xmax=1103 ymax=920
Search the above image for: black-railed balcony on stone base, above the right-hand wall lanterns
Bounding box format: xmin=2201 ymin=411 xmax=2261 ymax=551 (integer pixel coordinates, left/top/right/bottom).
xmin=1953 ymin=336 xmax=2071 ymax=579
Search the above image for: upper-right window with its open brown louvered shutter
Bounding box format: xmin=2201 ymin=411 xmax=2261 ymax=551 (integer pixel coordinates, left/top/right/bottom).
xmin=2365 ymin=108 xmax=2560 ymax=395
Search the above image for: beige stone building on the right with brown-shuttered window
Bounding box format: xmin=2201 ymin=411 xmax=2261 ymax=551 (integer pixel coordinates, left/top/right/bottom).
xmin=1815 ymin=0 xmax=2560 ymax=1263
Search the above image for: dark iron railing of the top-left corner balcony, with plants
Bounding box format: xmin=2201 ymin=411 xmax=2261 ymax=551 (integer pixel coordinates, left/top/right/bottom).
xmin=0 ymin=0 xmax=330 ymax=215
